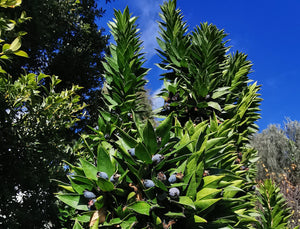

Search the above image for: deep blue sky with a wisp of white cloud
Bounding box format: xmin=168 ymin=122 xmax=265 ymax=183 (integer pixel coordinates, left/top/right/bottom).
xmin=99 ymin=0 xmax=300 ymax=130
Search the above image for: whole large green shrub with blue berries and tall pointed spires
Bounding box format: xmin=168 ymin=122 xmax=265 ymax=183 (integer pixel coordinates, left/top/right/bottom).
xmin=57 ymin=1 xmax=270 ymax=228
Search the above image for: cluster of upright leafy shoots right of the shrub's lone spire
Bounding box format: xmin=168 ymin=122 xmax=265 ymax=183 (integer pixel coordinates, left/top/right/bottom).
xmin=157 ymin=1 xmax=261 ymax=138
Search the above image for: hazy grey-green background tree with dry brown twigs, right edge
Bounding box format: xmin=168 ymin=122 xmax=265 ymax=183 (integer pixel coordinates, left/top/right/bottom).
xmin=251 ymin=119 xmax=300 ymax=226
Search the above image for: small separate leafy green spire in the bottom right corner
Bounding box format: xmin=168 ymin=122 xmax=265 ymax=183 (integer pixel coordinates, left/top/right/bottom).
xmin=257 ymin=179 xmax=291 ymax=229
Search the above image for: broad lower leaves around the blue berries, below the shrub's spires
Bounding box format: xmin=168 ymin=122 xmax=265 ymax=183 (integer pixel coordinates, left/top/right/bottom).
xmin=57 ymin=115 xmax=256 ymax=228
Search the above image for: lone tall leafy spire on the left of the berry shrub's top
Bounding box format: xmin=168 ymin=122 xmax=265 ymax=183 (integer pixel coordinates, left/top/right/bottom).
xmin=103 ymin=8 xmax=149 ymax=131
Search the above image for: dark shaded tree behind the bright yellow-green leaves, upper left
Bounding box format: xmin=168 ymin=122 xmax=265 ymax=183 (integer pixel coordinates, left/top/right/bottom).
xmin=0 ymin=0 xmax=109 ymax=129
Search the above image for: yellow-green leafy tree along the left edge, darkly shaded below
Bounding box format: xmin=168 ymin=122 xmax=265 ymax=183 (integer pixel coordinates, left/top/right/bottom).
xmin=0 ymin=0 xmax=84 ymax=228
